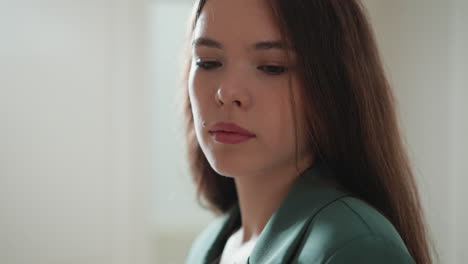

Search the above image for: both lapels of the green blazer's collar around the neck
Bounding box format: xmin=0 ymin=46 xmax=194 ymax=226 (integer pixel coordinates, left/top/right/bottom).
xmin=205 ymin=163 xmax=349 ymax=264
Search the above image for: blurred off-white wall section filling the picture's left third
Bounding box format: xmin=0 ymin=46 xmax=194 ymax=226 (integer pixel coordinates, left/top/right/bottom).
xmin=0 ymin=0 xmax=154 ymax=264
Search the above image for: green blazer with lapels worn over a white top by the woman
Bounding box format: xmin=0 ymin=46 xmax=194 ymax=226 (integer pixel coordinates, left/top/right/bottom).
xmin=186 ymin=165 xmax=415 ymax=264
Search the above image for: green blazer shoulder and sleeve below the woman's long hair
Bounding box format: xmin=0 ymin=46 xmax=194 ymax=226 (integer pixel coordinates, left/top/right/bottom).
xmin=296 ymin=196 xmax=414 ymax=264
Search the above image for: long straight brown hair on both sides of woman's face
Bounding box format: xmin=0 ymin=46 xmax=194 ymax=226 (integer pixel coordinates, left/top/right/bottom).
xmin=184 ymin=0 xmax=432 ymax=264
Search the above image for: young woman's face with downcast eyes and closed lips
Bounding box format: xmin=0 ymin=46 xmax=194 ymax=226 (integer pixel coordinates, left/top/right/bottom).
xmin=188 ymin=0 xmax=312 ymax=177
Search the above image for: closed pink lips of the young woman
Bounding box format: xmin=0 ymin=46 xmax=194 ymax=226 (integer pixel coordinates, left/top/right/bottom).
xmin=209 ymin=122 xmax=256 ymax=144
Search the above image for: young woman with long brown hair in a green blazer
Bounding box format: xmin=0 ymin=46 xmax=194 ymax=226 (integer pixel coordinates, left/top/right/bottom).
xmin=181 ymin=0 xmax=432 ymax=264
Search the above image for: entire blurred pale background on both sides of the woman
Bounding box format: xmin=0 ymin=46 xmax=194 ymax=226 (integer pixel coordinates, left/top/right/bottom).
xmin=0 ymin=0 xmax=468 ymax=264
